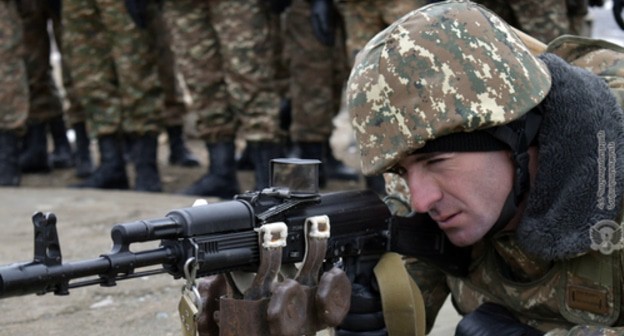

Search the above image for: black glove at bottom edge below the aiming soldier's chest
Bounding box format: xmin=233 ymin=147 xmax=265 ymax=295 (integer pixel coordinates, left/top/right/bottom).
xmin=455 ymin=302 xmax=544 ymax=336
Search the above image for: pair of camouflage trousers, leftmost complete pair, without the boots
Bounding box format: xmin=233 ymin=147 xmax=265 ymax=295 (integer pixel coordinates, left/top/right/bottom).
xmin=63 ymin=0 xmax=162 ymax=136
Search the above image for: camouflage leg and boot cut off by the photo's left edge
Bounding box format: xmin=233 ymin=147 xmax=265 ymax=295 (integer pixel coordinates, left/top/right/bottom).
xmin=0 ymin=0 xmax=28 ymax=186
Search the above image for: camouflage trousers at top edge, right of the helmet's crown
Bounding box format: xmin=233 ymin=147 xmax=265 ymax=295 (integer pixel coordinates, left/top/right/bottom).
xmin=475 ymin=0 xmax=570 ymax=43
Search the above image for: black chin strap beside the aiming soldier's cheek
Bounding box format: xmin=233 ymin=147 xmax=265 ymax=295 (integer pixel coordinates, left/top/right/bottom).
xmin=487 ymin=110 xmax=542 ymax=236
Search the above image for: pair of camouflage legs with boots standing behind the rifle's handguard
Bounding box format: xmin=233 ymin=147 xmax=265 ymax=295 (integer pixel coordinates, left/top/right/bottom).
xmin=163 ymin=0 xmax=285 ymax=198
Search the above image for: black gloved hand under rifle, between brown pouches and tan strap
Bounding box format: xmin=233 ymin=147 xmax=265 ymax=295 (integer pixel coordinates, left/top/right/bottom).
xmin=335 ymin=277 xmax=388 ymax=336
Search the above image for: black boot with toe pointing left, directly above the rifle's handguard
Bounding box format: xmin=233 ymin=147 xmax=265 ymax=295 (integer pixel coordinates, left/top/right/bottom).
xmin=182 ymin=141 xmax=240 ymax=199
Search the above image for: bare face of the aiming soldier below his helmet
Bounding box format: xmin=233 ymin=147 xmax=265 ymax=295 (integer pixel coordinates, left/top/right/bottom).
xmin=399 ymin=151 xmax=514 ymax=246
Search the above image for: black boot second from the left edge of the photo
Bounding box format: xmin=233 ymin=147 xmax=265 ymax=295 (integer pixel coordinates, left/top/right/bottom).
xmin=19 ymin=123 xmax=50 ymax=173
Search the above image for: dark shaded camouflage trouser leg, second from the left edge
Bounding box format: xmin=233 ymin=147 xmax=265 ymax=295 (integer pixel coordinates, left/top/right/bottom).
xmin=18 ymin=0 xmax=63 ymax=123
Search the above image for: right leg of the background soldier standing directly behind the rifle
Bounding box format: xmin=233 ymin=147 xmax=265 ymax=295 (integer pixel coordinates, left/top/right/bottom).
xmin=211 ymin=0 xmax=285 ymax=189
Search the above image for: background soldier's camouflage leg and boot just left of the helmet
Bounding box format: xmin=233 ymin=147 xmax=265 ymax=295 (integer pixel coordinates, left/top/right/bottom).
xmin=284 ymin=0 xmax=359 ymax=187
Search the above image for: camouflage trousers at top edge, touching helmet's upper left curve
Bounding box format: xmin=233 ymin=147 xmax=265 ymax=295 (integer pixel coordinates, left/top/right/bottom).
xmin=340 ymin=0 xmax=427 ymax=64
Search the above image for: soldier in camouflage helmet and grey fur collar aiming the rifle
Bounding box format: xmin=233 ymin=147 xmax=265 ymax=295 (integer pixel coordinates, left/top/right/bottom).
xmin=338 ymin=2 xmax=624 ymax=335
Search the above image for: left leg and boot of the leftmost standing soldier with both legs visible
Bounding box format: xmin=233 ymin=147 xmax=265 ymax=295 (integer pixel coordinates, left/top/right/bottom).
xmin=63 ymin=0 xmax=128 ymax=189
